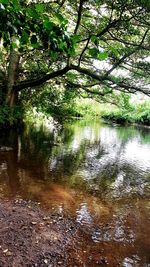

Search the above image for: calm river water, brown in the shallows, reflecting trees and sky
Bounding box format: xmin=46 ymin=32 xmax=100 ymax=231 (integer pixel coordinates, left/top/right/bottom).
xmin=0 ymin=121 xmax=150 ymax=267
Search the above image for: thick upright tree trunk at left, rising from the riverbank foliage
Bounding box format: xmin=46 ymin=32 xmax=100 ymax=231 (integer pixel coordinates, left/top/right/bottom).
xmin=6 ymin=49 xmax=20 ymax=107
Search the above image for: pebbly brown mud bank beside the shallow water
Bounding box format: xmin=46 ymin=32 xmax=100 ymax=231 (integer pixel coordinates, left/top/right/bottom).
xmin=0 ymin=200 xmax=79 ymax=267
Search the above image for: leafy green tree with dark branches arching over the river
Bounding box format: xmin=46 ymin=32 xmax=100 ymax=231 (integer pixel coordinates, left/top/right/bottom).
xmin=0 ymin=0 xmax=150 ymax=119
